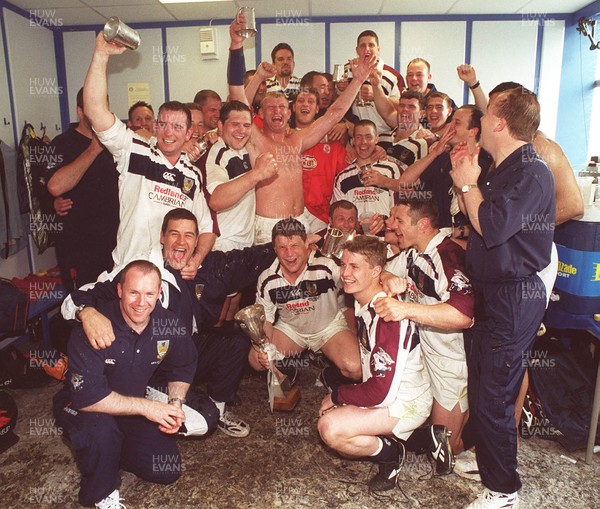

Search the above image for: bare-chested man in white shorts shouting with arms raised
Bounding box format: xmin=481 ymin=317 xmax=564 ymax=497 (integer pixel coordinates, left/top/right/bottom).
xmin=228 ymin=17 xmax=376 ymax=243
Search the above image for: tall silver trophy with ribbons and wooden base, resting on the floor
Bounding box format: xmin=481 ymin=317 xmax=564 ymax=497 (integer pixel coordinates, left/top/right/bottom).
xmin=234 ymin=304 xmax=300 ymax=412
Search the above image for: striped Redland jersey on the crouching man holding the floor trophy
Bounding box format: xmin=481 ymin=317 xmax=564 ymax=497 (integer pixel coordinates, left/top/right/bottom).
xmin=256 ymin=252 xmax=345 ymax=334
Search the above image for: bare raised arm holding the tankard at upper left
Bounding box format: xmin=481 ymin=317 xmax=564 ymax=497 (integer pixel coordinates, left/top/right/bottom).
xmin=83 ymin=33 xmax=127 ymax=132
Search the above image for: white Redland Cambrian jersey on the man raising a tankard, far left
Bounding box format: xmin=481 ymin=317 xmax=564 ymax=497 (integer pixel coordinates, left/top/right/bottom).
xmin=96 ymin=117 xmax=219 ymax=265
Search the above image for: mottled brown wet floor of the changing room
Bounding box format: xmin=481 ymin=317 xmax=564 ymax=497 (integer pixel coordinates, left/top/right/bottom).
xmin=0 ymin=360 xmax=600 ymax=509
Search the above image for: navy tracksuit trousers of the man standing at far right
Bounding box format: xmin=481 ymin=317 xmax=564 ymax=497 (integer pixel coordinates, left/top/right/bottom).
xmin=464 ymin=275 xmax=546 ymax=493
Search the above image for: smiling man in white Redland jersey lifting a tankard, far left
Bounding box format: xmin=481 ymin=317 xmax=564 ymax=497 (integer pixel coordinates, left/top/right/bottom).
xmin=83 ymin=34 xmax=218 ymax=278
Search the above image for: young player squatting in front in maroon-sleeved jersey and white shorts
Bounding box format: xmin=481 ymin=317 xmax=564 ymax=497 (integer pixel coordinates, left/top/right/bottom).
xmin=318 ymin=235 xmax=436 ymax=492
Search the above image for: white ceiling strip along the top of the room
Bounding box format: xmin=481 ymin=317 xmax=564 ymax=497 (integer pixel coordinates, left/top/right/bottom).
xmin=8 ymin=0 xmax=592 ymax=26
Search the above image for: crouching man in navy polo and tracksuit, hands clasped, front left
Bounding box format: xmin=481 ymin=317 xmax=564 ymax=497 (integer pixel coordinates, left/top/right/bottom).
xmin=54 ymin=260 xmax=197 ymax=509
